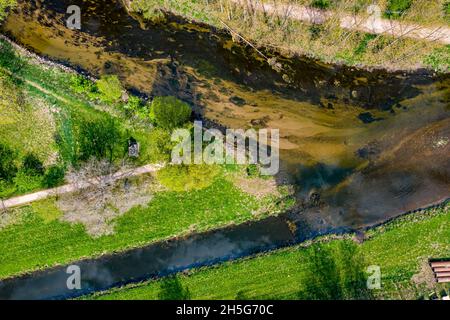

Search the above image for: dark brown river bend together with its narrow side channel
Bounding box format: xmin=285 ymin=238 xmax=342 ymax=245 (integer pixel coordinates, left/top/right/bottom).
xmin=0 ymin=0 xmax=450 ymax=299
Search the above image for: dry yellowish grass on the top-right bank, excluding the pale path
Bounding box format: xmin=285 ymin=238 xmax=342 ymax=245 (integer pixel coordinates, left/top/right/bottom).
xmin=131 ymin=0 xmax=450 ymax=72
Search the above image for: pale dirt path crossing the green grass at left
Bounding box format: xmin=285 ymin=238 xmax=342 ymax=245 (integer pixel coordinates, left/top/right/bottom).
xmin=0 ymin=164 xmax=164 ymax=209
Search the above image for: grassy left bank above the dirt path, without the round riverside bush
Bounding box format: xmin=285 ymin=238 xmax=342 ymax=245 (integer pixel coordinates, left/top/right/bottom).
xmin=0 ymin=40 xmax=156 ymax=198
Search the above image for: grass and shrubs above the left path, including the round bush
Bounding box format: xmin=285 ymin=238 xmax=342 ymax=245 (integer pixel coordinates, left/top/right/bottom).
xmin=0 ymin=41 xmax=195 ymax=198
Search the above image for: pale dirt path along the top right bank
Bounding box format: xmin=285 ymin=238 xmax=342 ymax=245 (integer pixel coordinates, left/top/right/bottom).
xmin=232 ymin=0 xmax=450 ymax=44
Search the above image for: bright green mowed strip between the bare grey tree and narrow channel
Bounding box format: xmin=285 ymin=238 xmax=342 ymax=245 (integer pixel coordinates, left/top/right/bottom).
xmin=0 ymin=178 xmax=260 ymax=278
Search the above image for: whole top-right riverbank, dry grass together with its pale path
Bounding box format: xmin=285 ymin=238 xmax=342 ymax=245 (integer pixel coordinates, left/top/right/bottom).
xmin=123 ymin=0 xmax=450 ymax=73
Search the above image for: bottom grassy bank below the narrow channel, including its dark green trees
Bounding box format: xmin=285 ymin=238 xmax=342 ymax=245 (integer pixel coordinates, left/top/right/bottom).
xmin=88 ymin=206 xmax=450 ymax=300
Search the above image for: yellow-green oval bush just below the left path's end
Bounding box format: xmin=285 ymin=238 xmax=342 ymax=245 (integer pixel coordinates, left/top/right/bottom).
xmin=157 ymin=165 xmax=220 ymax=192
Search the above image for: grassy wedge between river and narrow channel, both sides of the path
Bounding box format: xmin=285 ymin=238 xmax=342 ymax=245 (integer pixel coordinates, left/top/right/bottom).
xmin=0 ymin=41 xmax=292 ymax=279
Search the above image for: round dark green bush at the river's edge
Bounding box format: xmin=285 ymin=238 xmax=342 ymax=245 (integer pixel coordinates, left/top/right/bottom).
xmin=150 ymin=97 xmax=192 ymax=130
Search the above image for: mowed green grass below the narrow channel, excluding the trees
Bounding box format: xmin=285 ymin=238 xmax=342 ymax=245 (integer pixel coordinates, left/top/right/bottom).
xmin=87 ymin=206 xmax=450 ymax=300
